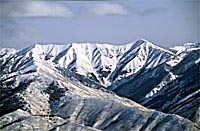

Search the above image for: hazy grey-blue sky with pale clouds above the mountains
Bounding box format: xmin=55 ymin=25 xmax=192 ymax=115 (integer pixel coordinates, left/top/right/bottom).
xmin=0 ymin=0 xmax=200 ymax=48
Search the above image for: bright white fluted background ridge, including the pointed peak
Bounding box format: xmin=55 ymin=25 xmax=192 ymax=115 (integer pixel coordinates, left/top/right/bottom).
xmin=26 ymin=39 xmax=174 ymax=86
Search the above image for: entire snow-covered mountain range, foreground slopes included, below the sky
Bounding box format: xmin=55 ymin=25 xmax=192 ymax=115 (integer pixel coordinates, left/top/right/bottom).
xmin=0 ymin=39 xmax=200 ymax=131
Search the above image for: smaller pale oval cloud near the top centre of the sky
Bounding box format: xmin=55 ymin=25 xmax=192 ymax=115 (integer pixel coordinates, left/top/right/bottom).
xmin=90 ymin=3 xmax=129 ymax=15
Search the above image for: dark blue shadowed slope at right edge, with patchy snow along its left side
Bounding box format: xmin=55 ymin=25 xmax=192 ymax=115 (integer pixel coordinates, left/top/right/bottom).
xmin=141 ymin=50 xmax=200 ymax=126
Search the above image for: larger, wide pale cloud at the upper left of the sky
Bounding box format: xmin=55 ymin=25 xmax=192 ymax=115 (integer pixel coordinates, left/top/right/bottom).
xmin=0 ymin=1 xmax=73 ymax=17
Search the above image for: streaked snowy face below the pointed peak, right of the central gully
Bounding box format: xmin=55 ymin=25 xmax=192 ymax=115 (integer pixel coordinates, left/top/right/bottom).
xmin=109 ymin=39 xmax=175 ymax=90
